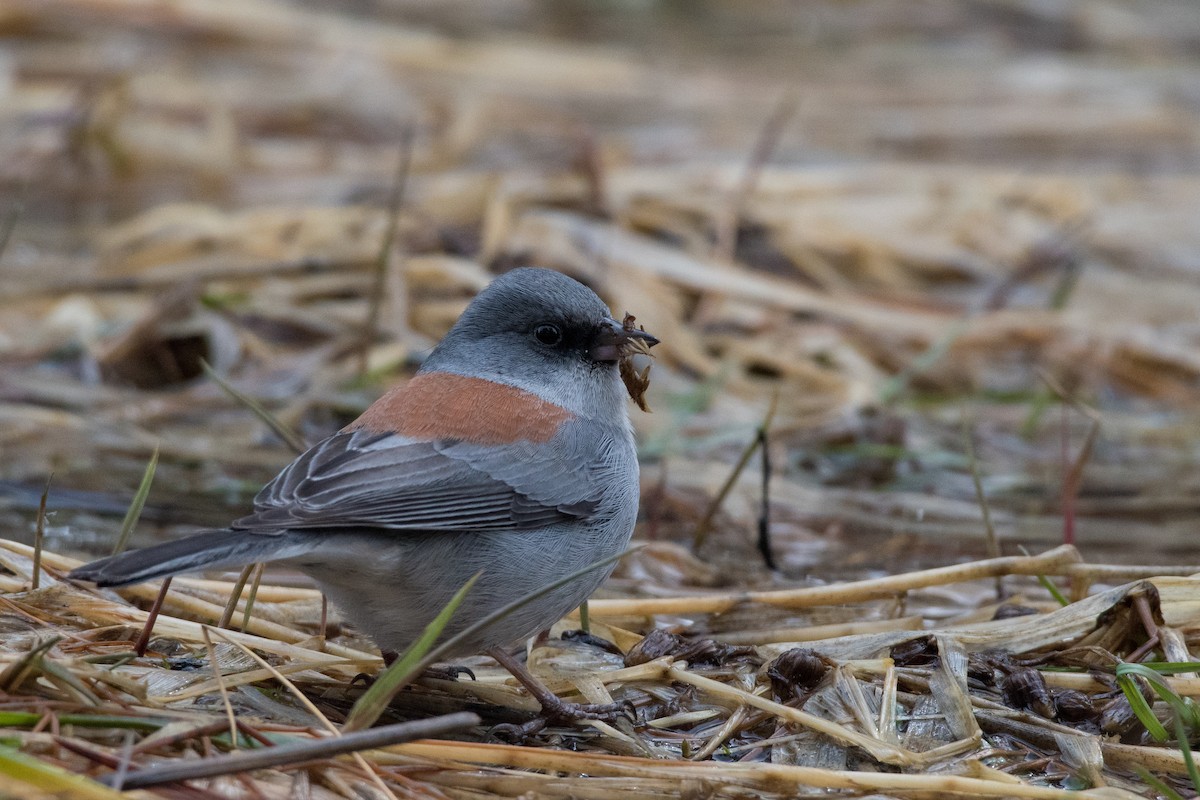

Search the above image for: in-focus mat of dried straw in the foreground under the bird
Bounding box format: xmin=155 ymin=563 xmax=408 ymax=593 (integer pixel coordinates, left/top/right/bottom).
xmin=0 ymin=542 xmax=1200 ymax=798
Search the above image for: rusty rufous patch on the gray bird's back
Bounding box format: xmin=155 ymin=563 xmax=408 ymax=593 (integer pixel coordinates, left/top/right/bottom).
xmin=344 ymin=372 xmax=574 ymax=445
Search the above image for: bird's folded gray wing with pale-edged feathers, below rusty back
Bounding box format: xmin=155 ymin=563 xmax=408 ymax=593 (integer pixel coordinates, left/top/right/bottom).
xmin=233 ymin=431 xmax=604 ymax=531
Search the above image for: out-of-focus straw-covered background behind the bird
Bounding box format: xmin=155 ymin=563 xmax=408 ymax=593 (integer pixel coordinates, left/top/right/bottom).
xmin=0 ymin=0 xmax=1200 ymax=591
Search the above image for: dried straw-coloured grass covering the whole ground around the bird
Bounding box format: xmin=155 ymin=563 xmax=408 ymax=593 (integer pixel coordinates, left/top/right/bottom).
xmin=0 ymin=0 xmax=1200 ymax=799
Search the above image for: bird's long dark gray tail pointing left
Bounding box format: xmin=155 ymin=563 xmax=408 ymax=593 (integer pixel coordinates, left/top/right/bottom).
xmin=67 ymin=529 xmax=319 ymax=587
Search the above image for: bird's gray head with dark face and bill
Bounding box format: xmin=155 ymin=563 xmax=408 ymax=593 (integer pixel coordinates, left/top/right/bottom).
xmin=421 ymin=267 xmax=658 ymax=417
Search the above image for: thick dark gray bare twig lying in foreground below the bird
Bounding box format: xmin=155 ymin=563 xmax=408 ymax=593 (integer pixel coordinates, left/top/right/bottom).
xmin=102 ymin=711 xmax=480 ymax=789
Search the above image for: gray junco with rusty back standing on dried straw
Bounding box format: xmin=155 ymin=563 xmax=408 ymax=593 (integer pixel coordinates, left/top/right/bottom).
xmin=70 ymin=269 xmax=658 ymax=724
